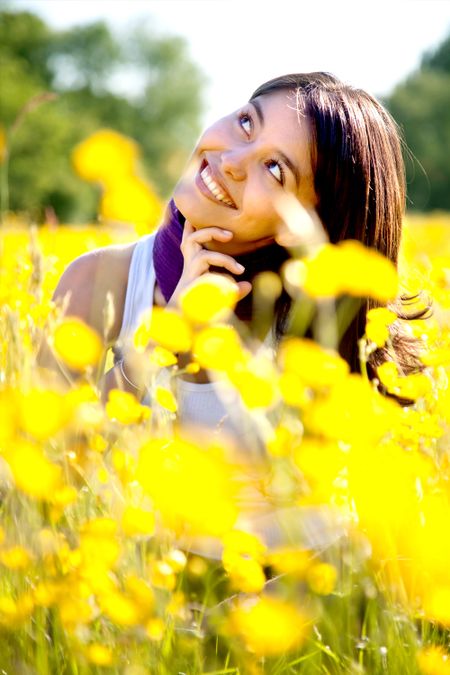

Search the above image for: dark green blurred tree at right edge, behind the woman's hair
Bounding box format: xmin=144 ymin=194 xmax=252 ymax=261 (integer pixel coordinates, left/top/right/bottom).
xmin=385 ymin=35 xmax=450 ymax=211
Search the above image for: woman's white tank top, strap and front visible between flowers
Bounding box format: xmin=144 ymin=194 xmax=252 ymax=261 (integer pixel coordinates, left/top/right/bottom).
xmin=118 ymin=233 xmax=260 ymax=452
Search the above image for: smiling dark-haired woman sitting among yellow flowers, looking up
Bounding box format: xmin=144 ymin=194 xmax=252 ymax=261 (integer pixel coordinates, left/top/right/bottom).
xmin=41 ymin=73 xmax=417 ymax=436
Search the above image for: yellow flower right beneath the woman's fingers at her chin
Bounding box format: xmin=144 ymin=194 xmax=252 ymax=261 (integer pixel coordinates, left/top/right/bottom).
xmin=179 ymin=273 xmax=239 ymax=324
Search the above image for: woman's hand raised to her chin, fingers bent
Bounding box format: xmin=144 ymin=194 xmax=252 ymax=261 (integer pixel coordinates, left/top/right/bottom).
xmin=168 ymin=220 xmax=252 ymax=306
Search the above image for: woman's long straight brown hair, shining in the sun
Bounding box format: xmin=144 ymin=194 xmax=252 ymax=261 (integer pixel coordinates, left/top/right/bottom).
xmin=250 ymin=72 xmax=425 ymax=375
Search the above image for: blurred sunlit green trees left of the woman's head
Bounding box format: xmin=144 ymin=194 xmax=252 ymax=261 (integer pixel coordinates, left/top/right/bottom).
xmin=0 ymin=10 xmax=203 ymax=222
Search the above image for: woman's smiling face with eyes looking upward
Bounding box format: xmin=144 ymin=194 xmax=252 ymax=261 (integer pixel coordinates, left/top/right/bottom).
xmin=174 ymin=91 xmax=317 ymax=255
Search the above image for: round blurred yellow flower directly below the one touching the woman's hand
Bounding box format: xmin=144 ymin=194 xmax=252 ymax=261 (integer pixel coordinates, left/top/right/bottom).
xmin=193 ymin=324 xmax=245 ymax=371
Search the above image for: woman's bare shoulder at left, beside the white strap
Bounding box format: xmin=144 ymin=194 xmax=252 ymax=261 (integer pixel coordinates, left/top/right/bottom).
xmin=53 ymin=242 xmax=137 ymax=342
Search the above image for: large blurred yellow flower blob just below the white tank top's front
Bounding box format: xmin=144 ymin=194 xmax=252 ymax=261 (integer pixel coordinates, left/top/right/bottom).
xmin=136 ymin=438 xmax=237 ymax=536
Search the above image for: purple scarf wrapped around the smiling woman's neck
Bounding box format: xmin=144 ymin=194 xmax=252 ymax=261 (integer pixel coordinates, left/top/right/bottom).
xmin=153 ymin=199 xmax=289 ymax=314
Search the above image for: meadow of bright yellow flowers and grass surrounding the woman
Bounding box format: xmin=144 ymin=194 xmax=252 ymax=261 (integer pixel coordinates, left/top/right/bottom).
xmin=0 ymin=129 xmax=450 ymax=675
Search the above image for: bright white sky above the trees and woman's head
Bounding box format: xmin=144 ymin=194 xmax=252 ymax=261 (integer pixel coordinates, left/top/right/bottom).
xmin=8 ymin=0 xmax=450 ymax=124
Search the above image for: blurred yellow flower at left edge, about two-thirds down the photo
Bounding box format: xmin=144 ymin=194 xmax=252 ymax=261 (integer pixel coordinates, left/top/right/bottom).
xmin=6 ymin=441 xmax=61 ymax=500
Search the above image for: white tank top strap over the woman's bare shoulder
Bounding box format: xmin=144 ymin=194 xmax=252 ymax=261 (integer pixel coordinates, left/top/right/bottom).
xmin=118 ymin=233 xmax=155 ymax=345
